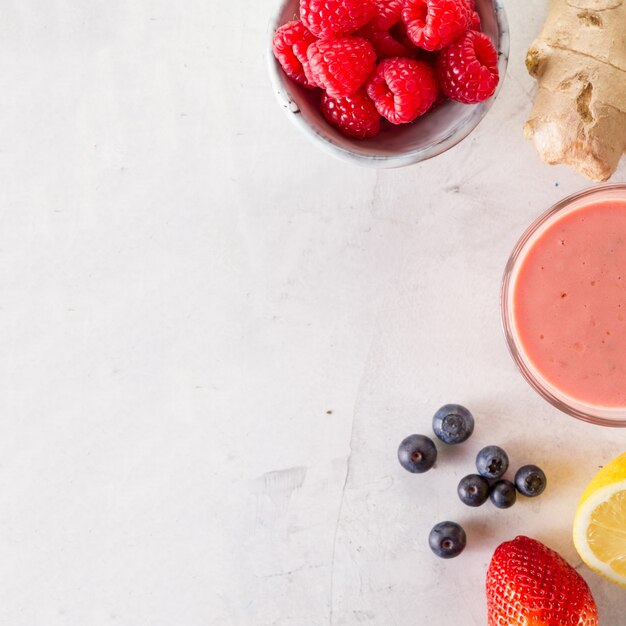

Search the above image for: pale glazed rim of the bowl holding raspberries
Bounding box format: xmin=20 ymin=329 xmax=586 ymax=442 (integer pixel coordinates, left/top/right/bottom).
xmin=266 ymin=0 xmax=510 ymax=168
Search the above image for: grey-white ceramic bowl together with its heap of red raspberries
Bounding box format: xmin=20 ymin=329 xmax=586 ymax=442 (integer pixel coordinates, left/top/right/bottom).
xmin=269 ymin=0 xmax=509 ymax=168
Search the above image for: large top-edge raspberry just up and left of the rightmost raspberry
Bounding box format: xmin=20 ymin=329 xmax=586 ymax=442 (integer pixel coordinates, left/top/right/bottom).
xmin=402 ymin=0 xmax=472 ymax=50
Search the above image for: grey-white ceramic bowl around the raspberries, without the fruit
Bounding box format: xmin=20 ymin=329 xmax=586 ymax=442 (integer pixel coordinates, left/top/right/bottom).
xmin=267 ymin=0 xmax=509 ymax=168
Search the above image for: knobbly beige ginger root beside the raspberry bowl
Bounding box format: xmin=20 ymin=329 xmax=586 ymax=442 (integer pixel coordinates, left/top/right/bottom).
xmin=524 ymin=0 xmax=626 ymax=181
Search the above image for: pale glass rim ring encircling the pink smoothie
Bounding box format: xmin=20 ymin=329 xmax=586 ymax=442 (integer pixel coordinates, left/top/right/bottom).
xmin=500 ymin=183 xmax=626 ymax=428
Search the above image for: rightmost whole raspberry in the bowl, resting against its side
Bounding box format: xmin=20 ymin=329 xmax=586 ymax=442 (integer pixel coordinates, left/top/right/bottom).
xmin=437 ymin=30 xmax=498 ymax=104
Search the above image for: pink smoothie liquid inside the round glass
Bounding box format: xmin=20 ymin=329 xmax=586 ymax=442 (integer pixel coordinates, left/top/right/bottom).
xmin=512 ymin=200 xmax=626 ymax=407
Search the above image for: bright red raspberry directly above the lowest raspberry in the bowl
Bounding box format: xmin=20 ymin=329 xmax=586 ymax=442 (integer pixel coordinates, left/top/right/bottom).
xmin=307 ymin=37 xmax=376 ymax=98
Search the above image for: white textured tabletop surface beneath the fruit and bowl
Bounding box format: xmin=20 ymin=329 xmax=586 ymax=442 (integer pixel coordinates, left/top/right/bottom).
xmin=0 ymin=0 xmax=626 ymax=626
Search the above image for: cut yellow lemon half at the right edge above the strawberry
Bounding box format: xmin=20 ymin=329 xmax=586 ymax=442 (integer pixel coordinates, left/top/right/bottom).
xmin=573 ymin=453 xmax=626 ymax=587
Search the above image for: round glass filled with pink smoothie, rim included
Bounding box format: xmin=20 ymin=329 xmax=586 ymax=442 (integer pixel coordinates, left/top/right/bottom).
xmin=500 ymin=184 xmax=626 ymax=426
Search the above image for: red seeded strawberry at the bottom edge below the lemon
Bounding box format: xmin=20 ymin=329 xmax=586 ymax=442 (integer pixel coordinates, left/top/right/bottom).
xmin=486 ymin=537 xmax=598 ymax=626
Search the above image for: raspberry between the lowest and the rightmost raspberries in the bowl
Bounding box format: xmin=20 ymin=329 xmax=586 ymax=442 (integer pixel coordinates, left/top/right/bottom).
xmin=366 ymin=57 xmax=438 ymax=124
